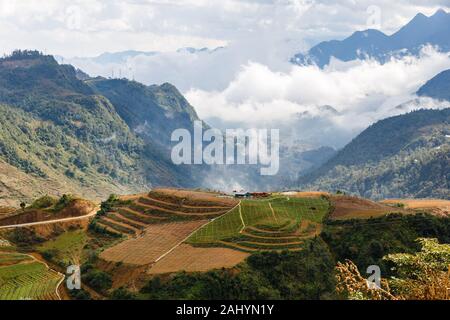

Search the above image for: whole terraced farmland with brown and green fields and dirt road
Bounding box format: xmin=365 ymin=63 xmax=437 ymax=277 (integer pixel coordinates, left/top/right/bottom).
xmin=0 ymin=188 xmax=450 ymax=299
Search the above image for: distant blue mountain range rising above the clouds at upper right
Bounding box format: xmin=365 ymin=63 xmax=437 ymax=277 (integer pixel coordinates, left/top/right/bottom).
xmin=291 ymin=9 xmax=450 ymax=68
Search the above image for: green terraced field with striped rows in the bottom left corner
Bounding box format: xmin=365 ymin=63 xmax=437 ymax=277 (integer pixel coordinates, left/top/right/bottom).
xmin=0 ymin=252 xmax=62 ymax=300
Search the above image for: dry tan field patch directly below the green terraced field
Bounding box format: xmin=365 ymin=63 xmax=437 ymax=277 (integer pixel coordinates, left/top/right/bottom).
xmin=148 ymin=244 xmax=249 ymax=274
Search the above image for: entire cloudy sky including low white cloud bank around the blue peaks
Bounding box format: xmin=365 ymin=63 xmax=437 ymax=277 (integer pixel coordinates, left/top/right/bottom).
xmin=0 ymin=0 xmax=450 ymax=147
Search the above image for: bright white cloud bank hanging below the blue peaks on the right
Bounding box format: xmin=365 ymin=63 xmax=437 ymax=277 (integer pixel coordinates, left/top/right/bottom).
xmin=186 ymin=48 xmax=450 ymax=146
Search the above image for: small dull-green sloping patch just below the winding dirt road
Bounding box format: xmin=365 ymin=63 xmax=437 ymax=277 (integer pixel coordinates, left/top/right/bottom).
xmin=37 ymin=230 xmax=87 ymax=266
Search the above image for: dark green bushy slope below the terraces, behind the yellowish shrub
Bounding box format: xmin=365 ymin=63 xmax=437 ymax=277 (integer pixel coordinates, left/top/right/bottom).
xmin=139 ymin=214 xmax=450 ymax=300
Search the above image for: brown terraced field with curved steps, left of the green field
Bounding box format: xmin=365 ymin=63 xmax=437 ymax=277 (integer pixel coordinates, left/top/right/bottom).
xmin=95 ymin=189 xmax=238 ymax=269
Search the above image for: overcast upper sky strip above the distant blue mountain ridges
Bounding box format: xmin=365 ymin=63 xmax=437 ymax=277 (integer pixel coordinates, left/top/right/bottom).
xmin=0 ymin=0 xmax=450 ymax=57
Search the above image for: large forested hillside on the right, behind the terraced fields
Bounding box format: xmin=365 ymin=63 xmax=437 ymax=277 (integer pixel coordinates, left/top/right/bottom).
xmin=300 ymin=109 xmax=450 ymax=199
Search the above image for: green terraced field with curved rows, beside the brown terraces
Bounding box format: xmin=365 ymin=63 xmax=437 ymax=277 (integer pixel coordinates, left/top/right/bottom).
xmin=187 ymin=197 xmax=330 ymax=252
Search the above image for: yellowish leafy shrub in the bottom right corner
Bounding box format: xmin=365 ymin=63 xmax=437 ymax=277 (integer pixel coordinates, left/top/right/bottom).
xmin=336 ymin=238 xmax=450 ymax=300
